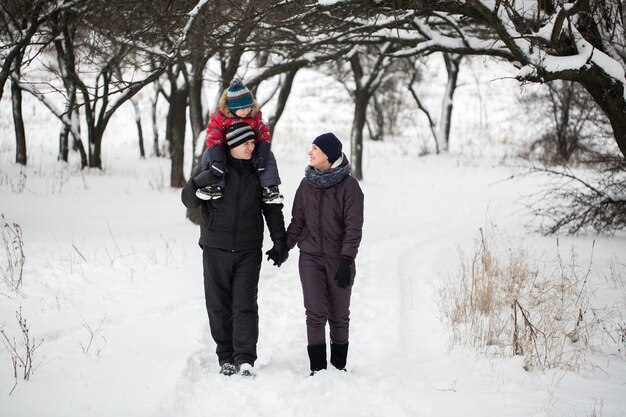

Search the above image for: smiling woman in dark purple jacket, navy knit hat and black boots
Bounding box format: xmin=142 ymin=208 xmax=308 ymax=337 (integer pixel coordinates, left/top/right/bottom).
xmin=287 ymin=133 xmax=363 ymax=375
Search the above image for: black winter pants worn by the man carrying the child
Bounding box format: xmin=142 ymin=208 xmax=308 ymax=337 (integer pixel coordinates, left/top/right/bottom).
xmin=203 ymin=247 xmax=263 ymax=365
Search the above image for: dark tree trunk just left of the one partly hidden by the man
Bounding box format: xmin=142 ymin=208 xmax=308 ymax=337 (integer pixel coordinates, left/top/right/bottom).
xmin=167 ymin=85 xmax=189 ymax=188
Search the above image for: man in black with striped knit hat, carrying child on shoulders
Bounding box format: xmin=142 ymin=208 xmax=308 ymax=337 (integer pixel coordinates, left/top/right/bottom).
xmin=181 ymin=123 xmax=288 ymax=377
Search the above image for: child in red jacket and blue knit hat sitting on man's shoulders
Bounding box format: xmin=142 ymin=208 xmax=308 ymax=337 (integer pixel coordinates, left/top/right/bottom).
xmin=196 ymin=78 xmax=283 ymax=204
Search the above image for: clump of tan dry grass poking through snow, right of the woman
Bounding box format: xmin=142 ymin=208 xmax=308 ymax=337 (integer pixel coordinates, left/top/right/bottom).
xmin=440 ymin=227 xmax=608 ymax=371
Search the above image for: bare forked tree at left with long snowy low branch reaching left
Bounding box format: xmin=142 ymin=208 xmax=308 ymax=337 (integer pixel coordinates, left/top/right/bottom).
xmin=13 ymin=0 xmax=205 ymax=168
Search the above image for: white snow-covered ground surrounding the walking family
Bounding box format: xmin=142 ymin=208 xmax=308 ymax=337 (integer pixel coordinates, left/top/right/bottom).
xmin=0 ymin=66 xmax=626 ymax=417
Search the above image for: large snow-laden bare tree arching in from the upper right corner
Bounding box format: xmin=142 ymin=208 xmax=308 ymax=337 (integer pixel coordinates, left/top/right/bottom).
xmin=320 ymin=0 xmax=626 ymax=160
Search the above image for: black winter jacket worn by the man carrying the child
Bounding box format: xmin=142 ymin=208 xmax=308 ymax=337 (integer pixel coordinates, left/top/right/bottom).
xmin=181 ymin=155 xmax=286 ymax=251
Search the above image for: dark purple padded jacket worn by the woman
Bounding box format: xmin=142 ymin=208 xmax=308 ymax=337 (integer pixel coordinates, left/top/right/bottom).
xmin=287 ymin=161 xmax=363 ymax=259
